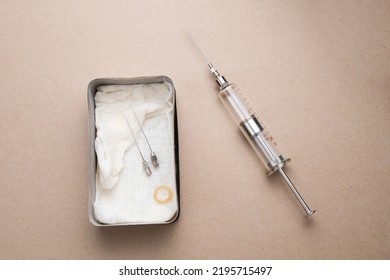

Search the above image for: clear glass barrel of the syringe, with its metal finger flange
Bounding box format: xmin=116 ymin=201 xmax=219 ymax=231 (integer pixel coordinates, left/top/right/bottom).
xmin=219 ymin=84 xmax=289 ymax=175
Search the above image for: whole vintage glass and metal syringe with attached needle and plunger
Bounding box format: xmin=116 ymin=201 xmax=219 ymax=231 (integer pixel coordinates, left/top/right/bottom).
xmin=190 ymin=35 xmax=315 ymax=217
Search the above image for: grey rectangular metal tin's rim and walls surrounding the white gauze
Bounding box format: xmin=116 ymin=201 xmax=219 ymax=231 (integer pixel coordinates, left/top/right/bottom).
xmin=87 ymin=76 xmax=180 ymax=227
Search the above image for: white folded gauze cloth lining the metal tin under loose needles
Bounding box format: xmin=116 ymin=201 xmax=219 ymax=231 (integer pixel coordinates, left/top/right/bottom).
xmin=94 ymin=83 xmax=178 ymax=224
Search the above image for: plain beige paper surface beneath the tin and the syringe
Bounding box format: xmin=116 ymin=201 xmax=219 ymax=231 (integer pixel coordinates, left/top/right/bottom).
xmin=0 ymin=0 xmax=390 ymax=259
